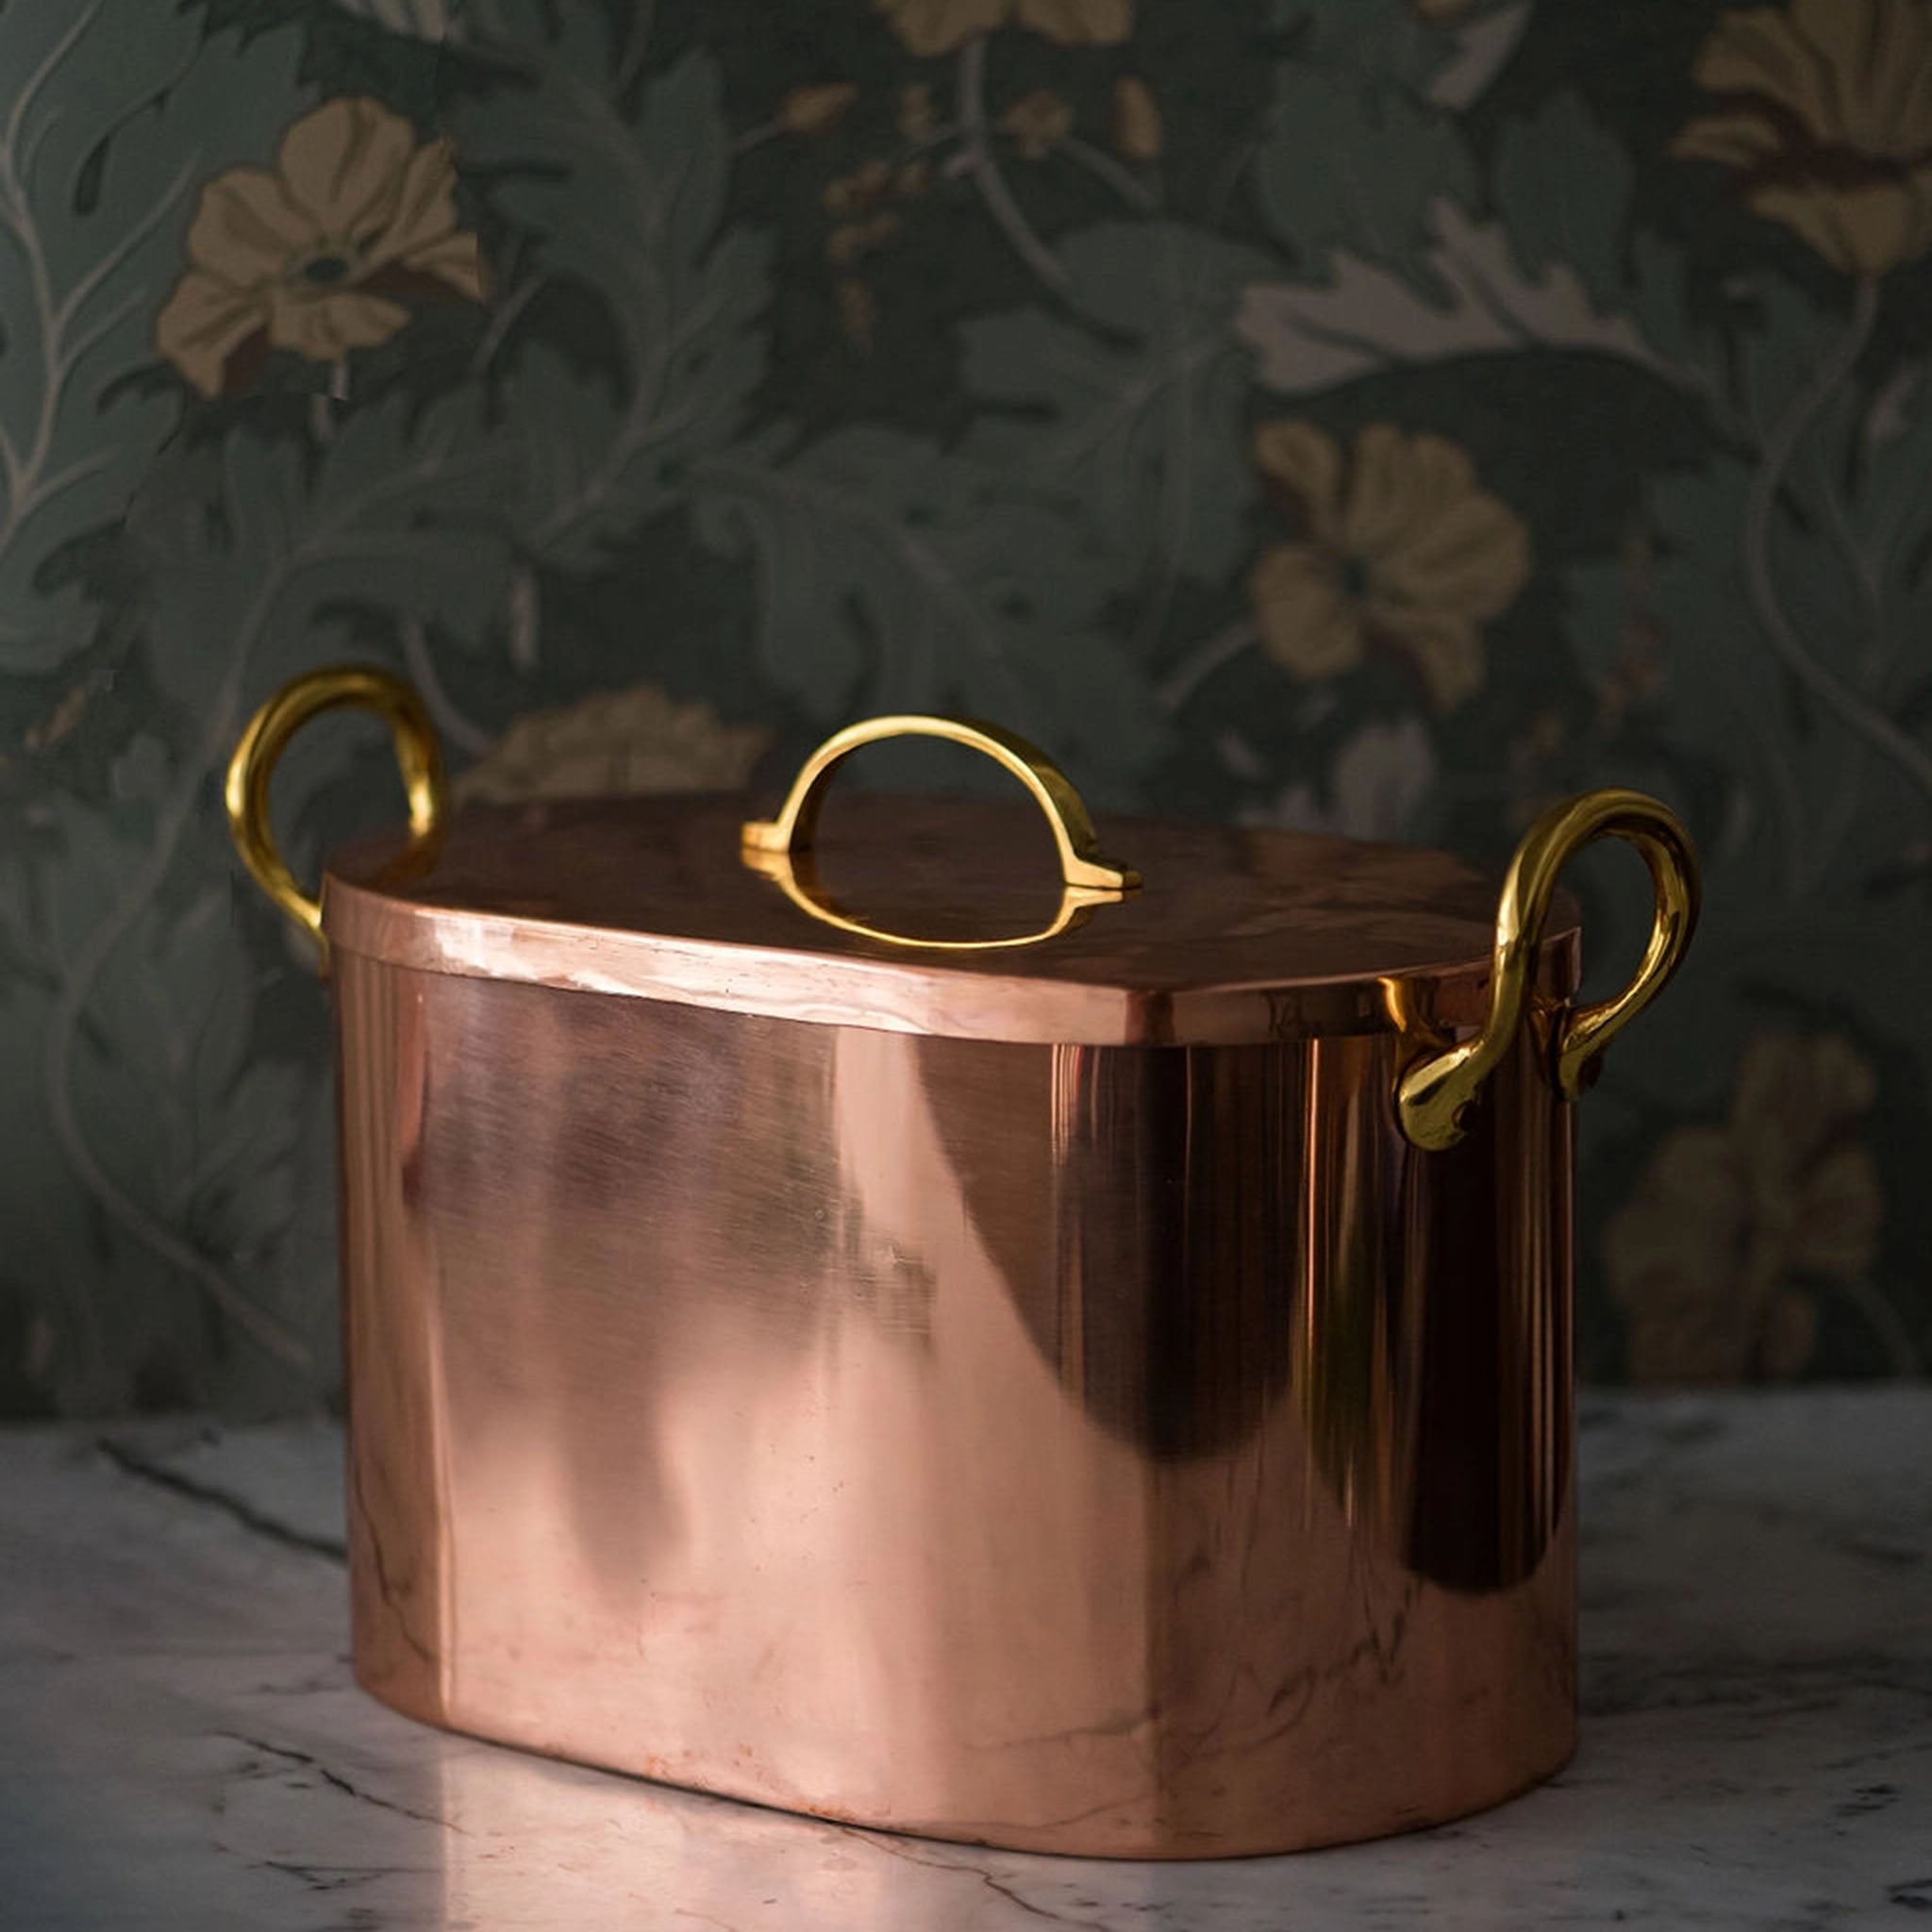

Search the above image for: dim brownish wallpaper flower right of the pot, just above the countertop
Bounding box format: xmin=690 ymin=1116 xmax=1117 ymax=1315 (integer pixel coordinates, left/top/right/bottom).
xmin=1604 ymin=1032 xmax=1884 ymax=1381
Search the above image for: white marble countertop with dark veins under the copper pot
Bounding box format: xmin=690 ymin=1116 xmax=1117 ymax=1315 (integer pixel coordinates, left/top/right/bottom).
xmin=0 ymin=1390 xmax=1932 ymax=1932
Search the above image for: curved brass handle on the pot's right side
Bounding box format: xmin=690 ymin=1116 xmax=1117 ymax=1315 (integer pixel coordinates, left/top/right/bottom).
xmin=1397 ymin=791 xmax=1698 ymax=1150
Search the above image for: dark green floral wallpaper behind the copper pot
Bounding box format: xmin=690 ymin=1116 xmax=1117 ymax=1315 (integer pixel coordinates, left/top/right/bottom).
xmin=0 ymin=0 xmax=1932 ymax=1414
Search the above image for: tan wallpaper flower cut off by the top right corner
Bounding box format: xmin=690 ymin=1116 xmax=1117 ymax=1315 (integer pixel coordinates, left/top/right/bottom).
xmin=1672 ymin=0 xmax=1932 ymax=275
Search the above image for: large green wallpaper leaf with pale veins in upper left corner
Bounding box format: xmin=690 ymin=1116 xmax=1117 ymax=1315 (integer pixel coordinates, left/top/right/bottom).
xmin=0 ymin=0 xmax=301 ymax=675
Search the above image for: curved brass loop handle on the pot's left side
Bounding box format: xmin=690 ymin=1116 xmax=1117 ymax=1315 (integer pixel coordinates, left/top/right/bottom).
xmin=226 ymin=665 xmax=448 ymax=968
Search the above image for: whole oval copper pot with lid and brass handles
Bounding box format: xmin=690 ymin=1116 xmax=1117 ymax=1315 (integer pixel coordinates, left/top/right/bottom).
xmin=228 ymin=667 xmax=1696 ymax=1858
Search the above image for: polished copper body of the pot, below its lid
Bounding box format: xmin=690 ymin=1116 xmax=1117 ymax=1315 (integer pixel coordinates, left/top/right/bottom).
xmin=332 ymin=935 xmax=1574 ymax=1857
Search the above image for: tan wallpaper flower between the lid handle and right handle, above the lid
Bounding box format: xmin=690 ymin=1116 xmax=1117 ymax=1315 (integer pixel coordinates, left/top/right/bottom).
xmin=1248 ymin=419 xmax=1530 ymax=711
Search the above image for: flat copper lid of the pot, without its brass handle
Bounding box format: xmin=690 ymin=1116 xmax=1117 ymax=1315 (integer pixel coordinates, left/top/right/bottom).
xmin=323 ymin=792 xmax=1578 ymax=1045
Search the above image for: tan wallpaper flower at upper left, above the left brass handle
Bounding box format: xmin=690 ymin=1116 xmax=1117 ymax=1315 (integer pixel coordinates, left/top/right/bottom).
xmin=155 ymin=98 xmax=483 ymax=396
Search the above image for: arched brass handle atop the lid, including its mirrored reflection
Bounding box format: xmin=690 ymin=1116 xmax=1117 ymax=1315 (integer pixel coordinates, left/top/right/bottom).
xmin=741 ymin=713 xmax=1140 ymax=953
